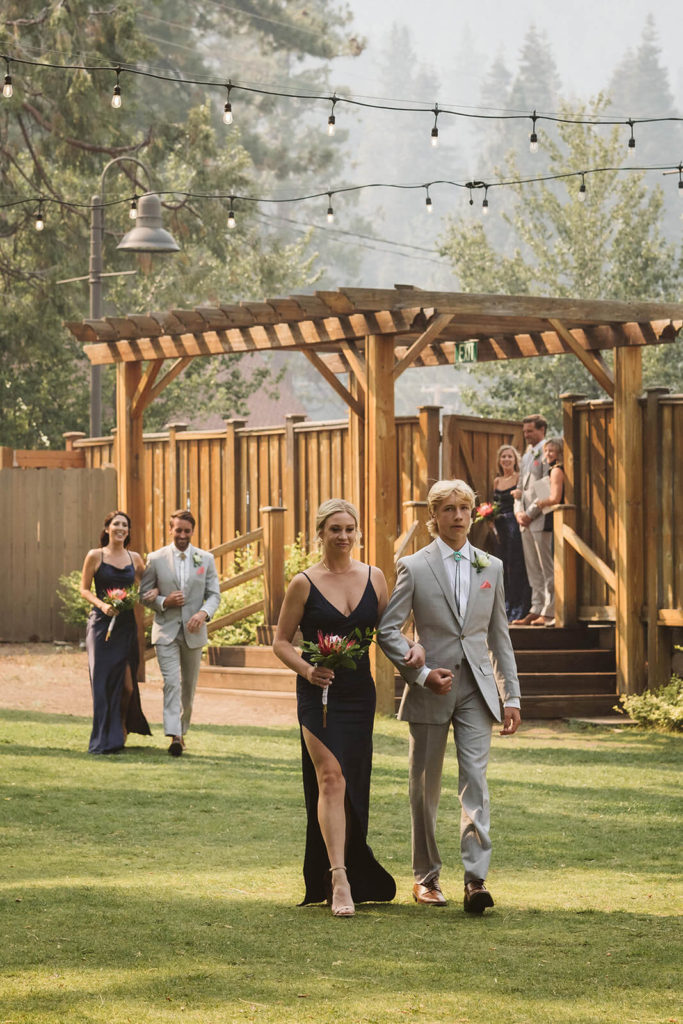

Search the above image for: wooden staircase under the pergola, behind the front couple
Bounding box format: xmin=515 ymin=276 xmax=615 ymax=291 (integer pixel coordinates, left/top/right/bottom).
xmin=199 ymin=626 xmax=617 ymax=719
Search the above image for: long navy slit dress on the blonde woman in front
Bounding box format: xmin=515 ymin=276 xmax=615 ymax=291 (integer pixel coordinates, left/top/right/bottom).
xmin=297 ymin=569 xmax=396 ymax=906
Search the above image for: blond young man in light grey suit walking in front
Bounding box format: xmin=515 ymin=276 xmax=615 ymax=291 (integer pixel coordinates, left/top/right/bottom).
xmin=378 ymin=480 xmax=521 ymax=913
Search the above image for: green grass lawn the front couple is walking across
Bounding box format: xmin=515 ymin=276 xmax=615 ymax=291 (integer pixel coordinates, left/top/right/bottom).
xmin=0 ymin=712 xmax=683 ymax=1024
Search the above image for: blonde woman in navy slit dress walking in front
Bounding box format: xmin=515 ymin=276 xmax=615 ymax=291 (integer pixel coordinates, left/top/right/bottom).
xmin=272 ymin=498 xmax=424 ymax=918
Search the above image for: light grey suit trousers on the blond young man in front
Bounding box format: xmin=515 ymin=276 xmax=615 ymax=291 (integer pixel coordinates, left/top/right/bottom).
xmin=409 ymin=660 xmax=494 ymax=883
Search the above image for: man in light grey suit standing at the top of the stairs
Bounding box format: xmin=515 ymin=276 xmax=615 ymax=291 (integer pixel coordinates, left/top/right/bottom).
xmin=512 ymin=415 xmax=555 ymax=626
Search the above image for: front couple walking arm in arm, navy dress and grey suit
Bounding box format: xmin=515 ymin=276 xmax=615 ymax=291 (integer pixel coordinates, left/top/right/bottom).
xmin=273 ymin=480 xmax=521 ymax=918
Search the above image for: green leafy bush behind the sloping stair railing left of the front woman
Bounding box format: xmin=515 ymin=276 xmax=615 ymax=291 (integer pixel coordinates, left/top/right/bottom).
xmin=209 ymin=534 xmax=318 ymax=647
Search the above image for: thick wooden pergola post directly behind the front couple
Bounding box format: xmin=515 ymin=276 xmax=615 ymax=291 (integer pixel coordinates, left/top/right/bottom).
xmin=365 ymin=335 xmax=398 ymax=715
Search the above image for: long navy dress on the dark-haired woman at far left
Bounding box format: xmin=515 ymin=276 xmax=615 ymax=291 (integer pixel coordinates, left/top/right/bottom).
xmin=85 ymin=558 xmax=152 ymax=754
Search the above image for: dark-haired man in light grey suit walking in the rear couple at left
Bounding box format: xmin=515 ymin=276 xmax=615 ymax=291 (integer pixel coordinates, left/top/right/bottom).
xmin=140 ymin=509 xmax=220 ymax=758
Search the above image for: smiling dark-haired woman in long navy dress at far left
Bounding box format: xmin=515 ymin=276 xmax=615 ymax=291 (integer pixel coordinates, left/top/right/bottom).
xmin=81 ymin=510 xmax=152 ymax=754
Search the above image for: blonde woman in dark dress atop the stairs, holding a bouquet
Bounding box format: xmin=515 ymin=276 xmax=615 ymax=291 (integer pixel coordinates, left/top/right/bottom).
xmin=494 ymin=444 xmax=531 ymax=623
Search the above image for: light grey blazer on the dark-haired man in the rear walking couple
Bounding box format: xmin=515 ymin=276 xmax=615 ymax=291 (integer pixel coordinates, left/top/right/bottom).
xmin=140 ymin=544 xmax=220 ymax=647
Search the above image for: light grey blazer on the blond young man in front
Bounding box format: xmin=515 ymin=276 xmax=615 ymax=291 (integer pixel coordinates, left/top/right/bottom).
xmin=377 ymin=542 xmax=520 ymax=724
